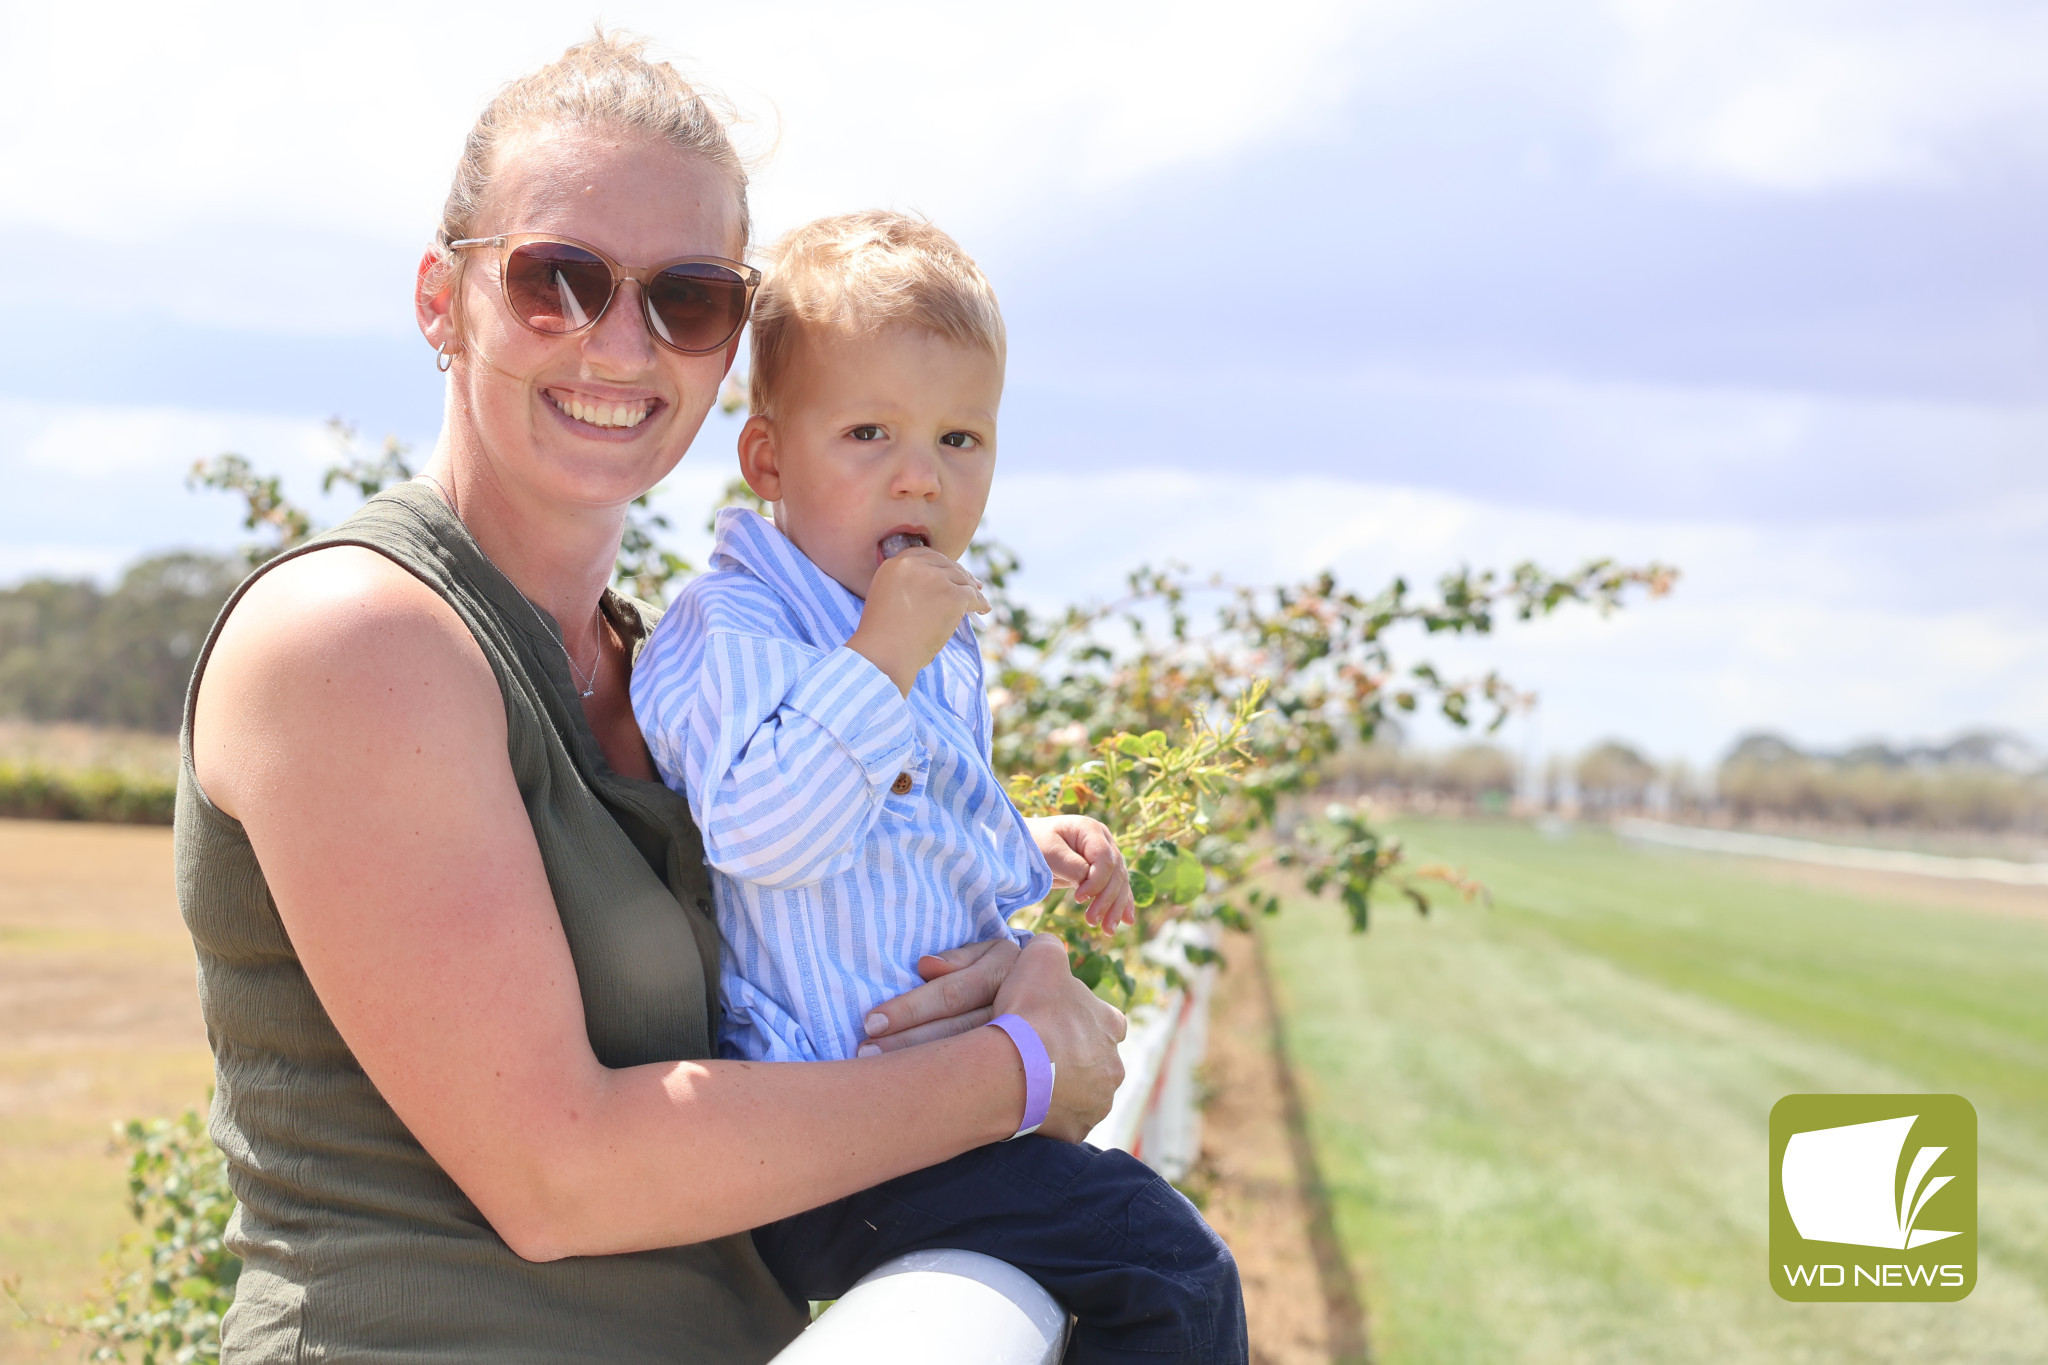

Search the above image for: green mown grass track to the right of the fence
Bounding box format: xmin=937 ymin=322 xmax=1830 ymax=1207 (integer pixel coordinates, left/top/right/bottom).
xmin=1262 ymin=823 xmax=2048 ymax=1365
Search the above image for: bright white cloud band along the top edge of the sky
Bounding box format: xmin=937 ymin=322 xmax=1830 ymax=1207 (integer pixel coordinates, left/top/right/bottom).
xmin=16 ymin=0 xmax=2048 ymax=341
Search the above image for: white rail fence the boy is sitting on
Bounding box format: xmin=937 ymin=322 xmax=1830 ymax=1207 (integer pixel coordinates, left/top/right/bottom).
xmin=774 ymin=929 xmax=1217 ymax=1365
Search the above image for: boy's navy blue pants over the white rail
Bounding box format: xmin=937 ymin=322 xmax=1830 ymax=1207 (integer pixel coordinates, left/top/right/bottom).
xmin=754 ymin=1136 xmax=1249 ymax=1365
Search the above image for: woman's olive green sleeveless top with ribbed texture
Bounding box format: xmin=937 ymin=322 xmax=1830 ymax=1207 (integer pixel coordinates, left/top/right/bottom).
xmin=176 ymin=483 xmax=803 ymax=1365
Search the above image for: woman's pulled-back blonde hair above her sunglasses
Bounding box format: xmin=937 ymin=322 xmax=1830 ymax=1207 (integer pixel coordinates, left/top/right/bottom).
xmin=438 ymin=29 xmax=754 ymax=263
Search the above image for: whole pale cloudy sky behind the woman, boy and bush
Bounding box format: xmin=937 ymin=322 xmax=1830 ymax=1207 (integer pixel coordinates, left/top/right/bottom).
xmin=0 ymin=0 xmax=2048 ymax=761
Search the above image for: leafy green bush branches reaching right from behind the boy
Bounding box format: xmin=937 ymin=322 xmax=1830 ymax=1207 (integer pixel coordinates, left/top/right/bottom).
xmin=971 ymin=542 xmax=1677 ymax=1001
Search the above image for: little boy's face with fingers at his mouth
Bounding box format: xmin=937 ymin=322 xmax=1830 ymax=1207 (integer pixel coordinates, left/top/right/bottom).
xmin=739 ymin=327 xmax=1004 ymax=598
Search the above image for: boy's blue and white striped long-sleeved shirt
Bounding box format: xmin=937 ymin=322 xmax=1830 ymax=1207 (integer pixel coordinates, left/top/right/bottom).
xmin=633 ymin=510 xmax=1053 ymax=1062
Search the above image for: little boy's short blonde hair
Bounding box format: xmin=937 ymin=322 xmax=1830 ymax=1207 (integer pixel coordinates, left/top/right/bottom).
xmin=748 ymin=209 xmax=1010 ymax=417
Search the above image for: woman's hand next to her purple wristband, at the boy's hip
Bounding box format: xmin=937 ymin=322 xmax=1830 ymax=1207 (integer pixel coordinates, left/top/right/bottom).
xmin=995 ymin=933 xmax=1130 ymax=1142
